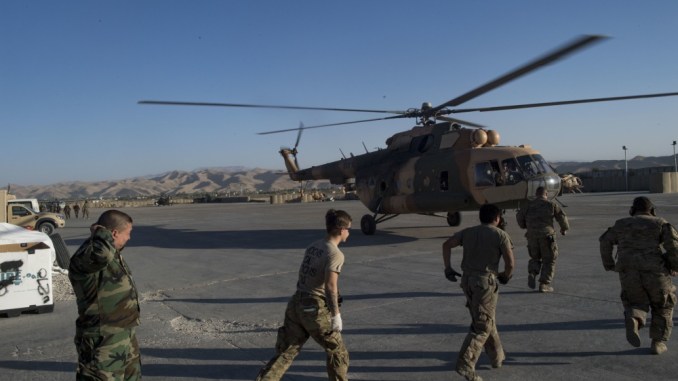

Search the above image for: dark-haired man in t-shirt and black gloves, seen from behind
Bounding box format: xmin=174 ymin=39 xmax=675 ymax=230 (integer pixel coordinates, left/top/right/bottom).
xmin=443 ymin=204 xmax=514 ymax=380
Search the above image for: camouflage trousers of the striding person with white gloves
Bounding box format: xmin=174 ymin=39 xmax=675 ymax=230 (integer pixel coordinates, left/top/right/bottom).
xmin=256 ymin=292 xmax=349 ymax=381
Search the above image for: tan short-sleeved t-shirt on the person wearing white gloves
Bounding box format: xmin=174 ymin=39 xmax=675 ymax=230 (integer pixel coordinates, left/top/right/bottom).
xmin=297 ymin=239 xmax=344 ymax=297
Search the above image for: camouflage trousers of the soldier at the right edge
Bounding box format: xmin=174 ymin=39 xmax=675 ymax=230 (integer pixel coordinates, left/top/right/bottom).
xmin=619 ymin=270 xmax=676 ymax=341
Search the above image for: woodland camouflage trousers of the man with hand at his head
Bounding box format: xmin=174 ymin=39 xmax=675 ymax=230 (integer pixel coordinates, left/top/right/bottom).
xmin=74 ymin=328 xmax=141 ymax=381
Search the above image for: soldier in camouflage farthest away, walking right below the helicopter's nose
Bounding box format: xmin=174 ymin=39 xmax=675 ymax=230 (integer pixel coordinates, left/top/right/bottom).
xmin=516 ymin=187 xmax=570 ymax=292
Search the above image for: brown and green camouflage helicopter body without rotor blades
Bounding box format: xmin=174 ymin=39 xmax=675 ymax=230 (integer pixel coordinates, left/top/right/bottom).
xmin=281 ymin=122 xmax=561 ymax=215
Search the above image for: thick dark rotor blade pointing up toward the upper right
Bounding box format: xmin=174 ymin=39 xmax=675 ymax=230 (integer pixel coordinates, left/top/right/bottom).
xmin=430 ymin=35 xmax=607 ymax=115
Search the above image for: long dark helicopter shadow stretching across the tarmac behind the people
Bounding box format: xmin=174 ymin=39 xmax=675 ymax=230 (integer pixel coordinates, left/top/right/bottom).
xmin=66 ymin=225 xmax=417 ymax=250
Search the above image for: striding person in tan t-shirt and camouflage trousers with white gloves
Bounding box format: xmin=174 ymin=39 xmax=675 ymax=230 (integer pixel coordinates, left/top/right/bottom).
xmin=256 ymin=209 xmax=351 ymax=381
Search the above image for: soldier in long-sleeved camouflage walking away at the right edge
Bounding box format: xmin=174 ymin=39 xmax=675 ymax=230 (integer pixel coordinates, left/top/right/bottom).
xmin=600 ymin=197 xmax=678 ymax=355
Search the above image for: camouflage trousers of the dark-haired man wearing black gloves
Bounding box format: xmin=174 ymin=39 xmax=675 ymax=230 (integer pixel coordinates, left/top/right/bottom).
xmin=456 ymin=273 xmax=504 ymax=370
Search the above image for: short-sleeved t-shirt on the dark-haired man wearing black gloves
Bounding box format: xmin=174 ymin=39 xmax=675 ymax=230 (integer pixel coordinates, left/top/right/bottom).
xmin=454 ymin=225 xmax=513 ymax=274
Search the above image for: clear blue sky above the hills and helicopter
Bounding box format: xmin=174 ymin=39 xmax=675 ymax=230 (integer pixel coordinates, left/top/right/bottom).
xmin=0 ymin=0 xmax=678 ymax=185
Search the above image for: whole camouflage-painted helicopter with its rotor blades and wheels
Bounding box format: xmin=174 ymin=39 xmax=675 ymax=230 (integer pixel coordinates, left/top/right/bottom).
xmin=139 ymin=36 xmax=678 ymax=235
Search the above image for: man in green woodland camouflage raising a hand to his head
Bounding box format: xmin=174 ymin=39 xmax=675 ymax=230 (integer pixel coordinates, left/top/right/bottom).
xmin=68 ymin=210 xmax=141 ymax=381
